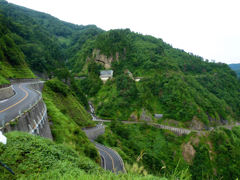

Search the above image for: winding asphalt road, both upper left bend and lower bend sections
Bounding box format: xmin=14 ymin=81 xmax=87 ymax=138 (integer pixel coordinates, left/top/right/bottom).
xmin=0 ymin=82 xmax=125 ymax=173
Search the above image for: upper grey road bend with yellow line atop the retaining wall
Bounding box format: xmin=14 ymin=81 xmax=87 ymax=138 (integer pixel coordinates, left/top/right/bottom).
xmin=0 ymin=83 xmax=41 ymax=126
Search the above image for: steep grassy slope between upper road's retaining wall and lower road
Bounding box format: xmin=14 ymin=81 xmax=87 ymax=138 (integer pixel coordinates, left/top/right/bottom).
xmin=43 ymin=79 xmax=100 ymax=161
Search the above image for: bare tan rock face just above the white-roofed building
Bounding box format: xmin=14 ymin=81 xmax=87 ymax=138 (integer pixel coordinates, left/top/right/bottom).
xmin=92 ymin=49 xmax=119 ymax=69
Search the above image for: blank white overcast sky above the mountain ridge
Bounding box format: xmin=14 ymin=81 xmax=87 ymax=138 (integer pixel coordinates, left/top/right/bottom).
xmin=8 ymin=0 xmax=240 ymax=64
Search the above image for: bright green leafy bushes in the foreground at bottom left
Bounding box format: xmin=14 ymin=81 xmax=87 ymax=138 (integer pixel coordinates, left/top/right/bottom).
xmin=0 ymin=132 xmax=169 ymax=180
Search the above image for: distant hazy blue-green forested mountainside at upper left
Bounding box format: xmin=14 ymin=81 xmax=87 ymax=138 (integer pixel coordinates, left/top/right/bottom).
xmin=0 ymin=1 xmax=102 ymax=75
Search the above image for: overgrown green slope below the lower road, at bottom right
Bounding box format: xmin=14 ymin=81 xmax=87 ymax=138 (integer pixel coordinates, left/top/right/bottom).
xmin=97 ymin=121 xmax=240 ymax=179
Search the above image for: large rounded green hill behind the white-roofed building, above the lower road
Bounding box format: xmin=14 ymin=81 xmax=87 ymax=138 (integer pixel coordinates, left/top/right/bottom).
xmin=72 ymin=29 xmax=240 ymax=125
